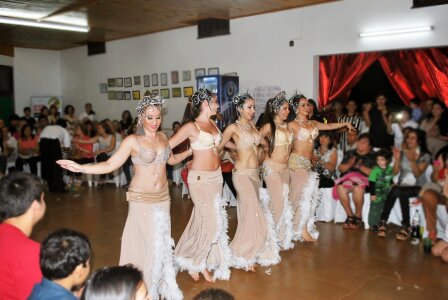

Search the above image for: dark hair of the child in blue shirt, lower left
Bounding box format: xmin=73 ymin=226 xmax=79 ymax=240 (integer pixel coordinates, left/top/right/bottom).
xmin=40 ymin=229 xmax=91 ymax=280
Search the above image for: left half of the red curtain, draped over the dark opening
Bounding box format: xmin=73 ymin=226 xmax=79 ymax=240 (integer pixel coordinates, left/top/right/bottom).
xmin=319 ymin=52 xmax=380 ymax=107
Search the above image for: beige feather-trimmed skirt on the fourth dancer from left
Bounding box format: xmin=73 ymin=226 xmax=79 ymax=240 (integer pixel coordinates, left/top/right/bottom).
xmin=260 ymin=160 xmax=294 ymax=250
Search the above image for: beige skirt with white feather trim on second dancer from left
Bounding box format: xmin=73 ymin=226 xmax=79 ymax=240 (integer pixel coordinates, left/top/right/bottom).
xmin=174 ymin=169 xmax=231 ymax=280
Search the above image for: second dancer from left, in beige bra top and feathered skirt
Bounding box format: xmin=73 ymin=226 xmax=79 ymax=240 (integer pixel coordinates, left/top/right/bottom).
xmin=170 ymin=89 xmax=231 ymax=281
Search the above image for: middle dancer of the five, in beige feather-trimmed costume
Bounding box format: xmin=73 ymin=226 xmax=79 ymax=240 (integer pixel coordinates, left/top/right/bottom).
xmin=221 ymin=93 xmax=280 ymax=272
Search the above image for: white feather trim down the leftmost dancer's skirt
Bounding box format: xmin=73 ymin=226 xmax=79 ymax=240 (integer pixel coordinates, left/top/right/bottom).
xmin=148 ymin=210 xmax=183 ymax=300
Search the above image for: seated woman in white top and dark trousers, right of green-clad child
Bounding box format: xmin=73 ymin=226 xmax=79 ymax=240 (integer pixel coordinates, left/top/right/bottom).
xmin=377 ymin=129 xmax=431 ymax=241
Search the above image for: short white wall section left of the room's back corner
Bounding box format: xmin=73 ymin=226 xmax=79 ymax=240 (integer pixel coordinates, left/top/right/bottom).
xmin=13 ymin=48 xmax=61 ymax=115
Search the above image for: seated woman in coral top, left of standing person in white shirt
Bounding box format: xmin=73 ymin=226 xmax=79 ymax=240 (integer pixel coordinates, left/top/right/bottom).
xmin=16 ymin=125 xmax=40 ymax=175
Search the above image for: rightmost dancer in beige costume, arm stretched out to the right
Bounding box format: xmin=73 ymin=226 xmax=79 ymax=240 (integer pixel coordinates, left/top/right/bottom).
xmin=289 ymin=95 xmax=354 ymax=242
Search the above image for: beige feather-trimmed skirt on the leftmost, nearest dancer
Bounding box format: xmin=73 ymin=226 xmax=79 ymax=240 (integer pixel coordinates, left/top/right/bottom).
xmin=120 ymin=184 xmax=183 ymax=300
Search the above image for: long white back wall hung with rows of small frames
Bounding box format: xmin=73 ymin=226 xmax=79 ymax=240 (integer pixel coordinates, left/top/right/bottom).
xmin=14 ymin=0 xmax=448 ymax=127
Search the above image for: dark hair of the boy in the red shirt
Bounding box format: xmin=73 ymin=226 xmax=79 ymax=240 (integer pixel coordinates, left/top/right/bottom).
xmin=0 ymin=172 xmax=45 ymax=222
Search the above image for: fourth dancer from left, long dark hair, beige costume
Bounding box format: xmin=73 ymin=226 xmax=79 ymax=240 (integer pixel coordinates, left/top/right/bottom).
xmin=260 ymin=92 xmax=294 ymax=250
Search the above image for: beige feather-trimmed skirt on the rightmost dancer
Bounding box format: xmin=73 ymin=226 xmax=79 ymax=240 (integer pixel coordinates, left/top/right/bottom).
xmin=289 ymin=153 xmax=319 ymax=241
